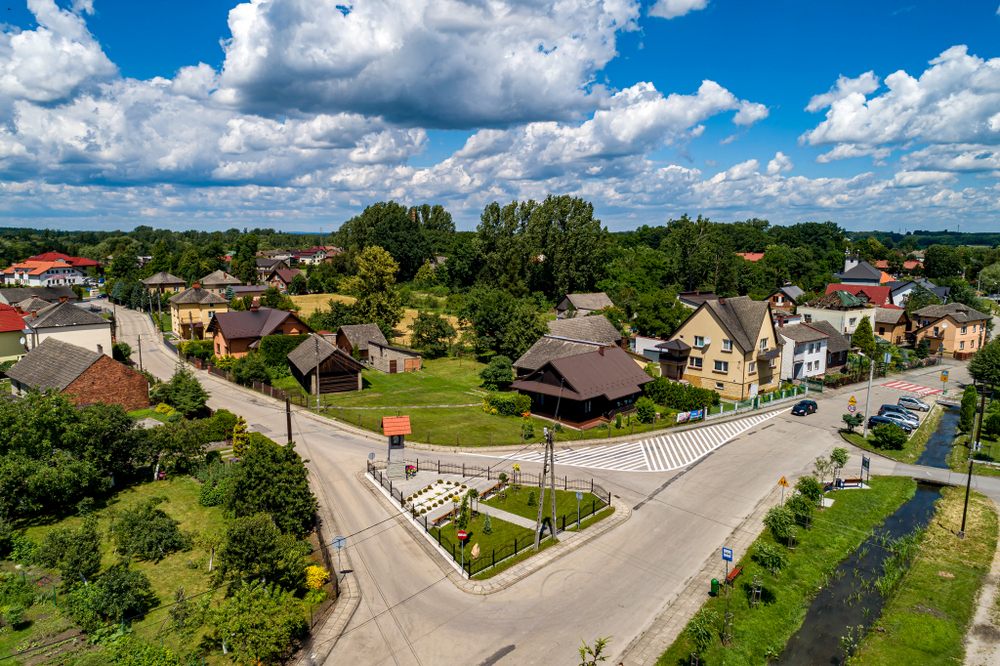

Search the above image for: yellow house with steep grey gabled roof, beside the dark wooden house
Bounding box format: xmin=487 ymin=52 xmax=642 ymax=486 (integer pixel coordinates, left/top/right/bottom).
xmin=660 ymin=296 xmax=781 ymax=400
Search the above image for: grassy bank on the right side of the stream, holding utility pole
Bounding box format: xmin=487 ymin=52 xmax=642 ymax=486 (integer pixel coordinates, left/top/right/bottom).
xmin=852 ymin=488 xmax=997 ymax=666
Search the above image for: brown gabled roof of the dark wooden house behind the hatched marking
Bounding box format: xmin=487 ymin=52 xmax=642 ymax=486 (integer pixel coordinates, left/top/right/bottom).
xmin=511 ymin=347 xmax=653 ymax=400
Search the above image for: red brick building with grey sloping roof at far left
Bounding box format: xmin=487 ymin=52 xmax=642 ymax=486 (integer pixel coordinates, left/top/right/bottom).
xmin=7 ymin=338 xmax=149 ymax=411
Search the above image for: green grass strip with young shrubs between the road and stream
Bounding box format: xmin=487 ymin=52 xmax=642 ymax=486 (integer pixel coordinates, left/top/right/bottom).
xmin=657 ymin=476 xmax=919 ymax=666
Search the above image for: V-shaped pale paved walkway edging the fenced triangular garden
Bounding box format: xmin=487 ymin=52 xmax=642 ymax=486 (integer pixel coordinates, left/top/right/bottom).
xmin=355 ymin=471 xmax=632 ymax=596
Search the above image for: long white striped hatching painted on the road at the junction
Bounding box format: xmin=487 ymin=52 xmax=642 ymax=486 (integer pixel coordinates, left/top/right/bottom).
xmin=468 ymin=409 xmax=784 ymax=472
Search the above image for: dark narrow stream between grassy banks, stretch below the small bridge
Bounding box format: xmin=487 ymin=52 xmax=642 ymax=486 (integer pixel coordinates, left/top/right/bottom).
xmin=776 ymin=484 xmax=941 ymax=666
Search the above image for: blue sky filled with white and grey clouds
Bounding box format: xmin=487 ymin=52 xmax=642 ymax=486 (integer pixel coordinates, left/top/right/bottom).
xmin=0 ymin=0 xmax=1000 ymax=231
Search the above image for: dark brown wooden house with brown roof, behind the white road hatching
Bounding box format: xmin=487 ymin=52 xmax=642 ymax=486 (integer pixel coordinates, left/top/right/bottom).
xmin=512 ymin=347 xmax=653 ymax=426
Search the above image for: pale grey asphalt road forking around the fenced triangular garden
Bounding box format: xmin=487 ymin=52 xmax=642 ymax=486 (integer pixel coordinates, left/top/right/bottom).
xmin=105 ymin=302 xmax=1000 ymax=665
